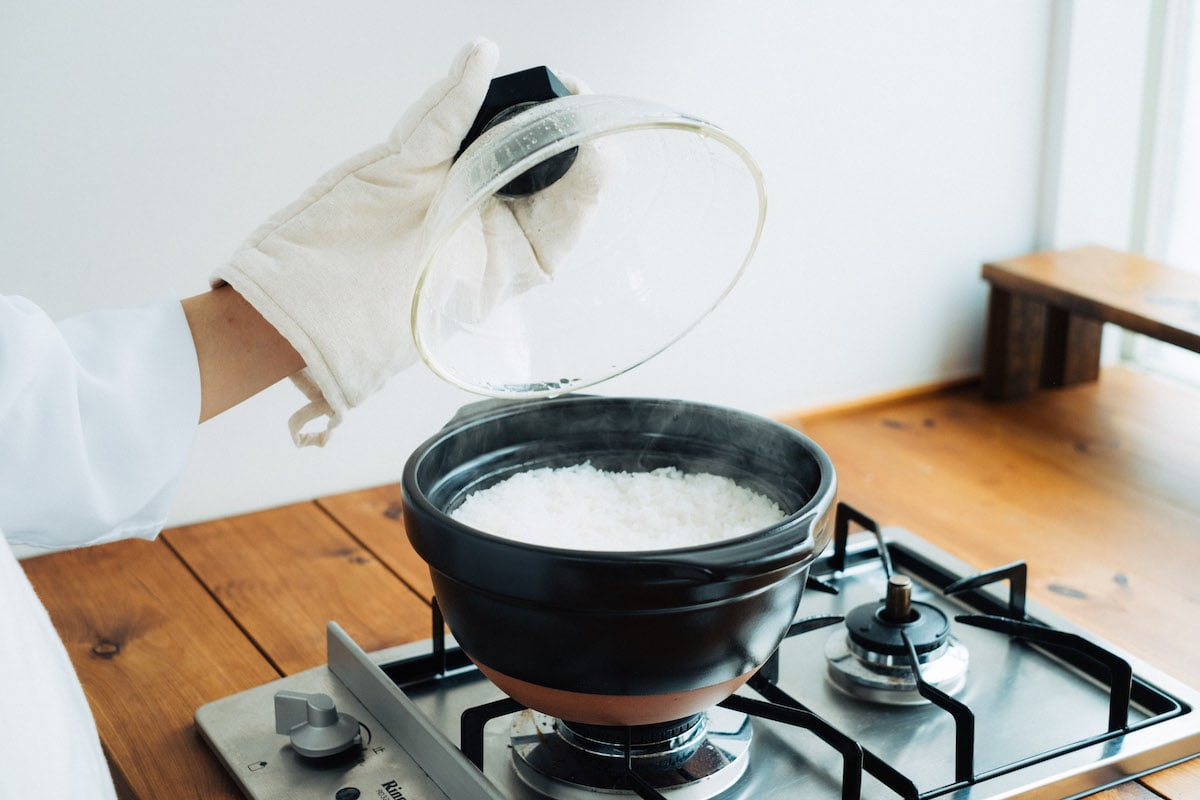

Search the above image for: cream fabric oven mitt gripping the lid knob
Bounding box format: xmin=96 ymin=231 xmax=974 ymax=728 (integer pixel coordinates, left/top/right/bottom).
xmin=212 ymin=40 xmax=602 ymax=446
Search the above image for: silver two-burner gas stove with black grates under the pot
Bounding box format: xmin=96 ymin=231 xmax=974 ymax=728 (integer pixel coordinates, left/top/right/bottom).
xmin=196 ymin=504 xmax=1200 ymax=800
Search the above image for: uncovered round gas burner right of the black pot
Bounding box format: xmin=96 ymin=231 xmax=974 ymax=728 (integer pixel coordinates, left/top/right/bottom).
xmin=826 ymin=575 xmax=968 ymax=705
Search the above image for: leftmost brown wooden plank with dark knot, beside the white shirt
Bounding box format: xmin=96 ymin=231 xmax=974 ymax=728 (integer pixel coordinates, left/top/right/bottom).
xmin=22 ymin=541 xmax=278 ymax=799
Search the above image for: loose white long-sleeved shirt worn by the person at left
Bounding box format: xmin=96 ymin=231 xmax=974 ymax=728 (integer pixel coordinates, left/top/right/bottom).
xmin=0 ymin=296 xmax=200 ymax=800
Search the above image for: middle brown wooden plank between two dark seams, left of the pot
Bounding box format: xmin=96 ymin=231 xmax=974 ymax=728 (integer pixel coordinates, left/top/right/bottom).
xmin=163 ymin=503 xmax=430 ymax=674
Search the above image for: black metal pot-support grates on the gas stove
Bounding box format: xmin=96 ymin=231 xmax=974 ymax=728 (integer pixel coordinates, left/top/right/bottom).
xmin=382 ymin=504 xmax=1184 ymax=800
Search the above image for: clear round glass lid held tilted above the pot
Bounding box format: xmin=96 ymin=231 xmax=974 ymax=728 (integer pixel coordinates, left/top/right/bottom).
xmin=412 ymin=95 xmax=766 ymax=397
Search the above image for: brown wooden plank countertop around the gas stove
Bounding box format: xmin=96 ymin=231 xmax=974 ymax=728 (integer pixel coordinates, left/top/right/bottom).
xmin=24 ymin=369 xmax=1200 ymax=800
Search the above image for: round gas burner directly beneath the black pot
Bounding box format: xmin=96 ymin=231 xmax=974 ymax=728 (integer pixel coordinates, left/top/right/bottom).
xmin=512 ymin=708 xmax=751 ymax=800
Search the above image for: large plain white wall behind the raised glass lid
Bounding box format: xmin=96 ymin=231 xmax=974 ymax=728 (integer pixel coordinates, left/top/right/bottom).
xmin=0 ymin=0 xmax=1051 ymax=522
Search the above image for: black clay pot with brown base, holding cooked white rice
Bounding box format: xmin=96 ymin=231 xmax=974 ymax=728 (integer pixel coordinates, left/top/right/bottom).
xmin=401 ymin=396 xmax=836 ymax=724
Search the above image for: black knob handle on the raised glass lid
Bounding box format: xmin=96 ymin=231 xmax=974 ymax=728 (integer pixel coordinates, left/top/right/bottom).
xmin=455 ymin=67 xmax=578 ymax=197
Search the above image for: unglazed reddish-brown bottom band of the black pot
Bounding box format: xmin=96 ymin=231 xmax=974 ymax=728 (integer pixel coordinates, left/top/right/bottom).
xmin=475 ymin=661 xmax=758 ymax=726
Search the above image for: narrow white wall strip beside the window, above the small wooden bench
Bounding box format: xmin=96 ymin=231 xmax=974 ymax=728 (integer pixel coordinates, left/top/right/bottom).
xmin=1037 ymin=0 xmax=1166 ymax=363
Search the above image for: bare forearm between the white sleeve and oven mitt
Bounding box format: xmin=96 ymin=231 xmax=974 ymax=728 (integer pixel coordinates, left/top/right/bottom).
xmin=182 ymin=285 xmax=305 ymax=422
